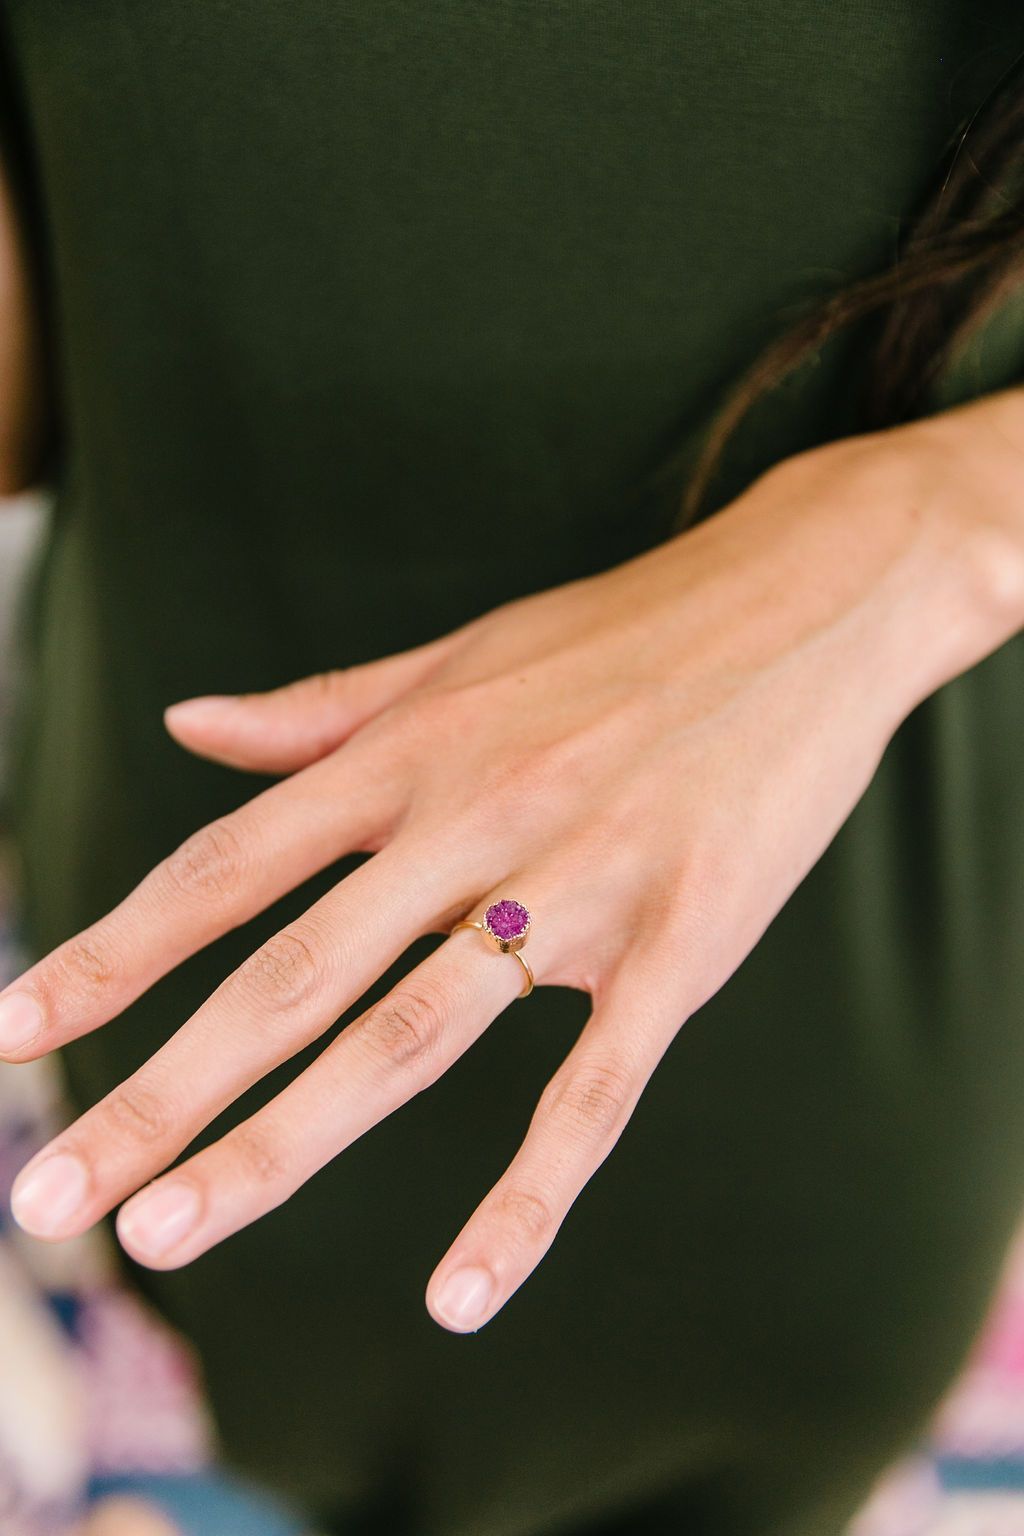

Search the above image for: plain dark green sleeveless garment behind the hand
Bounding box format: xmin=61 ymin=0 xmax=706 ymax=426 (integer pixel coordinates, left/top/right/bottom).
xmin=0 ymin=0 xmax=1024 ymax=1536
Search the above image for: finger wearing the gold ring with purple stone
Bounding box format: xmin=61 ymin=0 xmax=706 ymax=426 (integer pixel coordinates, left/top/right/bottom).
xmin=105 ymin=897 xmax=556 ymax=1269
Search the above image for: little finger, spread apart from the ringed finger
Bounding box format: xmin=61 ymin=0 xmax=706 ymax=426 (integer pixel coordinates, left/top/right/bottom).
xmin=427 ymin=966 xmax=683 ymax=1333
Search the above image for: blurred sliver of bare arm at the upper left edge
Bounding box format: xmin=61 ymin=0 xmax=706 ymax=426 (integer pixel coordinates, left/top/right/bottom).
xmin=0 ymin=147 xmax=43 ymax=496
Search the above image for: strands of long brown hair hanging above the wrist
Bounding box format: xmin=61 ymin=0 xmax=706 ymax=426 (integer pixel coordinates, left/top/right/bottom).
xmin=659 ymin=44 xmax=1024 ymax=531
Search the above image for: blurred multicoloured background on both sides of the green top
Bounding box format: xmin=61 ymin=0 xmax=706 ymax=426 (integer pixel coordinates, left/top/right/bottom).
xmin=0 ymin=498 xmax=1024 ymax=1536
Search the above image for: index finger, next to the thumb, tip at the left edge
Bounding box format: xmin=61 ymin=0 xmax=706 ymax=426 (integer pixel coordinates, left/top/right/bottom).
xmin=0 ymin=739 xmax=399 ymax=1061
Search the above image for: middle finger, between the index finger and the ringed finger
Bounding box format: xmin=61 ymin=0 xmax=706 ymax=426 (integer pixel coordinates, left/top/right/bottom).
xmin=12 ymin=839 xmax=506 ymax=1238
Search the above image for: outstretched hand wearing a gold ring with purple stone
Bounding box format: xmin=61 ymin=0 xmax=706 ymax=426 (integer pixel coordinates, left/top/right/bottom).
xmin=0 ymin=433 xmax=1007 ymax=1330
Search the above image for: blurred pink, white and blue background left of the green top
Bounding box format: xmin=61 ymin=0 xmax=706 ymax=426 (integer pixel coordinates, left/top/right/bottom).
xmin=0 ymin=496 xmax=315 ymax=1536
